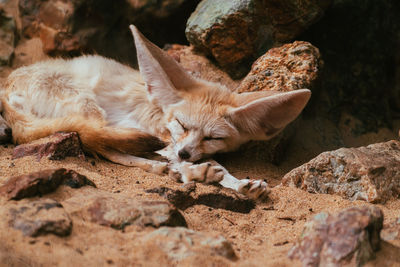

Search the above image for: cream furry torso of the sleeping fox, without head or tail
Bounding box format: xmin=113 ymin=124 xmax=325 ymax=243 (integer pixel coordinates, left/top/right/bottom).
xmin=4 ymin=56 xmax=169 ymax=142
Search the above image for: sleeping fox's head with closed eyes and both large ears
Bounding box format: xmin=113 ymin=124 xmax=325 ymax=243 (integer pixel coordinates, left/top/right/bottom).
xmin=130 ymin=25 xmax=311 ymax=161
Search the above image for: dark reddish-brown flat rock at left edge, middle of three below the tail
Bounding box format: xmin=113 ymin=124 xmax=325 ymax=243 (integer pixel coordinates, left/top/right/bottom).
xmin=0 ymin=168 xmax=95 ymax=200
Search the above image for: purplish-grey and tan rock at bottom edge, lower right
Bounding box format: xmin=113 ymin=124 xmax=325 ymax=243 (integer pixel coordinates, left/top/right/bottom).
xmin=288 ymin=206 xmax=383 ymax=266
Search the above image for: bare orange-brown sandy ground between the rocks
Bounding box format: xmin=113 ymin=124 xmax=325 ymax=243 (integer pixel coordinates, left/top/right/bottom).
xmin=0 ymin=116 xmax=400 ymax=266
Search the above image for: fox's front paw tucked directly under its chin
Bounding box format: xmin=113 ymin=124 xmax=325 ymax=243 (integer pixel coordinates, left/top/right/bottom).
xmin=173 ymin=162 xmax=224 ymax=183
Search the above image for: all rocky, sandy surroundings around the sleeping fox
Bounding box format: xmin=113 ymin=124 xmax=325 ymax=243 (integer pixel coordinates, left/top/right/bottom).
xmin=0 ymin=0 xmax=400 ymax=266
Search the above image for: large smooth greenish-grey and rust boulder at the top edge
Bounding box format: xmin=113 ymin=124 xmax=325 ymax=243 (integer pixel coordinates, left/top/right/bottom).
xmin=186 ymin=0 xmax=331 ymax=78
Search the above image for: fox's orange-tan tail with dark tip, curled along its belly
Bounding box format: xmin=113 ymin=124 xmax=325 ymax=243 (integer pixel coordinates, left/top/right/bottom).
xmin=4 ymin=103 xmax=165 ymax=156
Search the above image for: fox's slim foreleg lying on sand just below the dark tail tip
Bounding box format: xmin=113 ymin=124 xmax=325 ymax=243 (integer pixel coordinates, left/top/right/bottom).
xmin=102 ymin=151 xmax=168 ymax=175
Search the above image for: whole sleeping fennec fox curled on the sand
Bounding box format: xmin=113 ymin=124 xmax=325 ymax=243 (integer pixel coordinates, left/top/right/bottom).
xmin=1 ymin=25 xmax=310 ymax=199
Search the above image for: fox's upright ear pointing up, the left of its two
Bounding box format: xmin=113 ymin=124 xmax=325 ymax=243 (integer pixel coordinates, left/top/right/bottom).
xmin=129 ymin=25 xmax=197 ymax=107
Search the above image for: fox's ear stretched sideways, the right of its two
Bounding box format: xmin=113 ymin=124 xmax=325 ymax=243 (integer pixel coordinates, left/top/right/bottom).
xmin=227 ymin=89 xmax=311 ymax=139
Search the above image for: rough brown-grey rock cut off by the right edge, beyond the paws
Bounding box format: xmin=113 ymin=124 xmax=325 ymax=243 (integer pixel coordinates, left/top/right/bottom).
xmin=282 ymin=140 xmax=400 ymax=203
